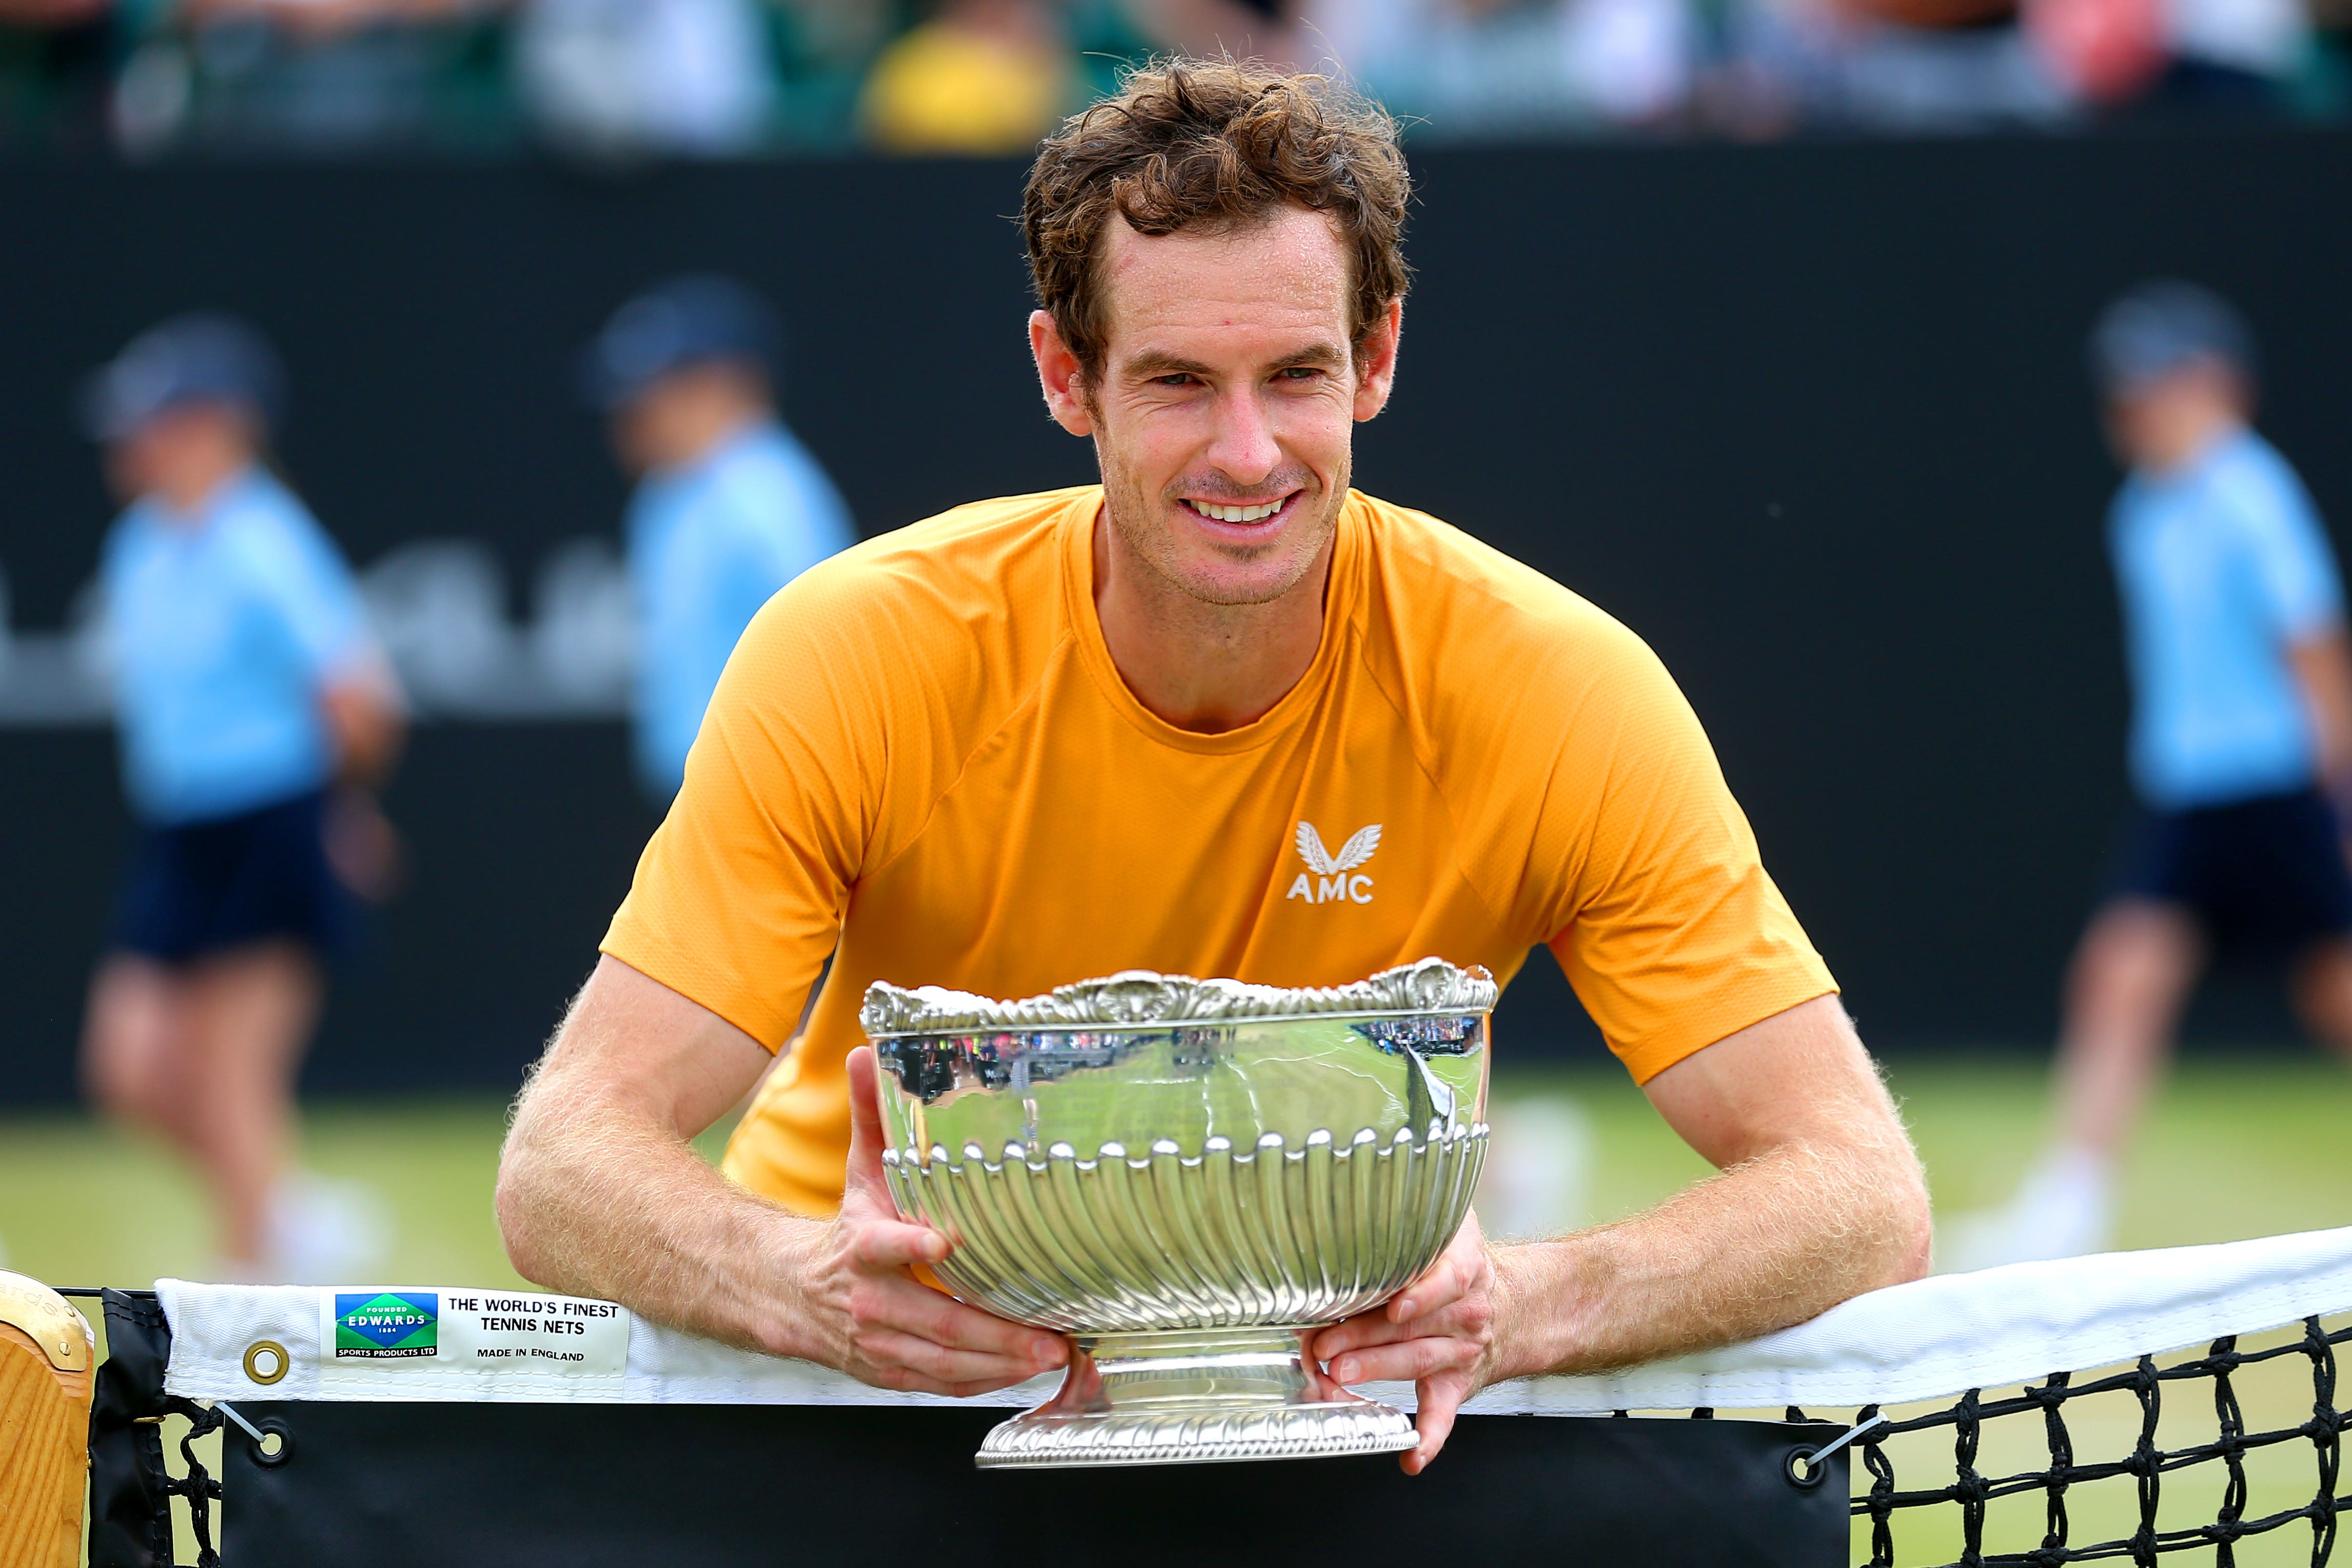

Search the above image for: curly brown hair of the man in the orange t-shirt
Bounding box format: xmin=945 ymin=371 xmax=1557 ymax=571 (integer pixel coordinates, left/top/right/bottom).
xmin=1021 ymin=59 xmax=1414 ymax=383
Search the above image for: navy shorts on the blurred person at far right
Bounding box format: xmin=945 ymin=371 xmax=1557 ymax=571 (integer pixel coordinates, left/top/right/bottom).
xmin=2107 ymin=790 xmax=2352 ymax=950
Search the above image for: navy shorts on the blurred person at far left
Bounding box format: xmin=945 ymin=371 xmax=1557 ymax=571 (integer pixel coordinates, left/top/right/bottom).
xmin=115 ymin=792 xmax=355 ymax=964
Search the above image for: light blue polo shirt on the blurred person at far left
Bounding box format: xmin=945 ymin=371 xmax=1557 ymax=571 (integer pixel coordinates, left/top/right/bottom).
xmin=101 ymin=468 xmax=371 ymax=825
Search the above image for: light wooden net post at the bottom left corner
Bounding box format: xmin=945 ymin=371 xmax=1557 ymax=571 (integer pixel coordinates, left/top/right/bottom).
xmin=0 ymin=1269 xmax=96 ymax=1568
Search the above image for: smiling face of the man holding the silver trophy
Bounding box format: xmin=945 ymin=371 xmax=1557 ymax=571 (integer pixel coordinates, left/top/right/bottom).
xmin=1032 ymin=207 xmax=1395 ymax=604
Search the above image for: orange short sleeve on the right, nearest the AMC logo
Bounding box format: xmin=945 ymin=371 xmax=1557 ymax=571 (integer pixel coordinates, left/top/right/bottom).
xmin=1536 ymin=628 xmax=1837 ymax=1084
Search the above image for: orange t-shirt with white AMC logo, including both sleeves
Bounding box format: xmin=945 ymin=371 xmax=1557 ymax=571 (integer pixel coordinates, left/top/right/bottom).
xmin=604 ymin=484 xmax=1835 ymax=1216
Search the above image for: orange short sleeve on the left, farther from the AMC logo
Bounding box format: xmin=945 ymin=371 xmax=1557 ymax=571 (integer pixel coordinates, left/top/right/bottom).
xmin=602 ymin=571 xmax=885 ymax=1051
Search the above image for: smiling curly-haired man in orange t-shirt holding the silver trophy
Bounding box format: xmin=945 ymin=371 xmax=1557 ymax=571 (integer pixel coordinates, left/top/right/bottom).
xmin=499 ymin=61 xmax=1929 ymax=1472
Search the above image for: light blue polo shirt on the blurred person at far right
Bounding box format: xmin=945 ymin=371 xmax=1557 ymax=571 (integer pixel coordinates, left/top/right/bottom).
xmin=2107 ymin=430 xmax=2343 ymax=811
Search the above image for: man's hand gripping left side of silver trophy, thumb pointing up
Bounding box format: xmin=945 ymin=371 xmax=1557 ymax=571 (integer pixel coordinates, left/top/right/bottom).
xmin=797 ymin=1046 xmax=1070 ymax=1399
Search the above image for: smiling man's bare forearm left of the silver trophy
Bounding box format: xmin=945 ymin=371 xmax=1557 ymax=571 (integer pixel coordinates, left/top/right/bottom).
xmin=499 ymin=1082 xmax=823 ymax=1357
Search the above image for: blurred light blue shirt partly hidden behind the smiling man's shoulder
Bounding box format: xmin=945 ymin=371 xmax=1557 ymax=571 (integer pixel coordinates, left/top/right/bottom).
xmin=628 ymin=421 xmax=856 ymax=804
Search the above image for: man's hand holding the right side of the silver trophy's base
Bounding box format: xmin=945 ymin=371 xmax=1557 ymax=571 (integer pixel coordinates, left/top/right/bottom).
xmin=1312 ymin=1213 xmax=1510 ymax=1476
